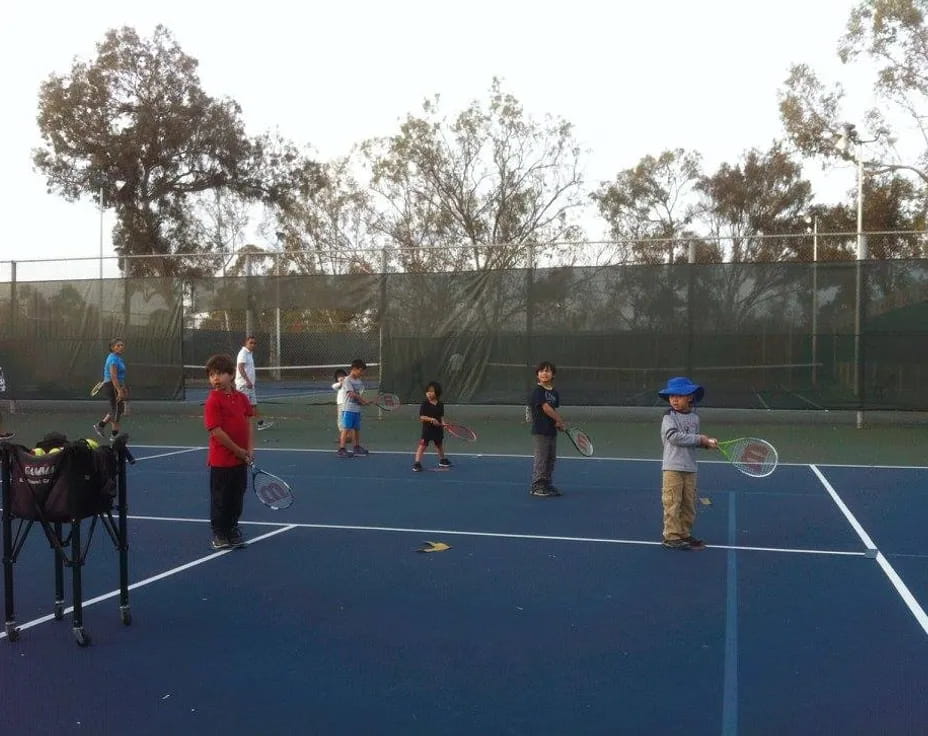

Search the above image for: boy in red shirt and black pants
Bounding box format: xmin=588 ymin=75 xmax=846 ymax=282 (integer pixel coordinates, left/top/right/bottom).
xmin=203 ymin=355 xmax=254 ymax=549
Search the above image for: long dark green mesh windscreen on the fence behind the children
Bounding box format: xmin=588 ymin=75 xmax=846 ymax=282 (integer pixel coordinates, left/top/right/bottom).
xmin=0 ymin=260 xmax=928 ymax=410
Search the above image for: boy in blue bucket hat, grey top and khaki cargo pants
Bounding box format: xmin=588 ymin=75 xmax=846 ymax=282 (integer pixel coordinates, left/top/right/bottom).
xmin=657 ymin=376 xmax=719 ymax=550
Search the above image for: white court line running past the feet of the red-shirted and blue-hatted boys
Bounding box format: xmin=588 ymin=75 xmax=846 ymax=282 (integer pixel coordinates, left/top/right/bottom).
xmin=127 ymin=516 xmax=866 ymax=557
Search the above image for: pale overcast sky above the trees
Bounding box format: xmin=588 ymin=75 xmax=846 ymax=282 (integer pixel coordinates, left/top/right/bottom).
xmin=0 ymin=0 xmax=872 ymax=281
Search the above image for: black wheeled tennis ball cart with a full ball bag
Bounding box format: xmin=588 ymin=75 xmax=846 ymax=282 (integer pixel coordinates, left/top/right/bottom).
xmin=0 ymin=434 xmax=135 ymax=647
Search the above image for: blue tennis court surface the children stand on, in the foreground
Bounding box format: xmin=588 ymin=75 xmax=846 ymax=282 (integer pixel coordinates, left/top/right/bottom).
xmin=0 ymin=446 xmax=928 ymax=736
